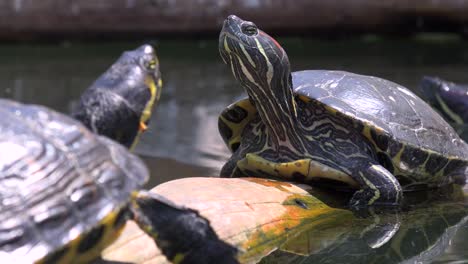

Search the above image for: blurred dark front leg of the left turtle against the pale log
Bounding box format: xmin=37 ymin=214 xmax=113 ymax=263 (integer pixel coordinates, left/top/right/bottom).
xmin=130 ymin=191 xmax=238 ymax=263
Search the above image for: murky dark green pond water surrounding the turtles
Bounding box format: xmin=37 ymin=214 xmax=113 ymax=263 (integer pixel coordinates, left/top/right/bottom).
xmin=0 ymin=38 xmax=468 ymax=263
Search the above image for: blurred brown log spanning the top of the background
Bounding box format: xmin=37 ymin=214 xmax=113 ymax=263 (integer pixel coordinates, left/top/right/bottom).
xmin=0 ymin=0 xmax=468 ymax=39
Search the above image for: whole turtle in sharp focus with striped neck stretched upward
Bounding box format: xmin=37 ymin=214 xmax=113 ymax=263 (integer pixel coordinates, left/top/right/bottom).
xmin=218 ymin=15 xmax=468 ymax=209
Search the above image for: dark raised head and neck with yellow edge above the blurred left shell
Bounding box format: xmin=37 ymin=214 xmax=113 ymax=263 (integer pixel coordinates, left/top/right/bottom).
xmin=72 ymin=45 xmax=162 ymax=150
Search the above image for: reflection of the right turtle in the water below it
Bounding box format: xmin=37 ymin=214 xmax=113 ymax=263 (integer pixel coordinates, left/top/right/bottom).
xmin=261 ymin=189 xmax=468 ymax=264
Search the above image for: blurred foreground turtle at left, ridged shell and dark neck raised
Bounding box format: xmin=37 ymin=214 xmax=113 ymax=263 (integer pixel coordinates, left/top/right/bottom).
xmin=0 ymin=45 xmax=208 ymax=264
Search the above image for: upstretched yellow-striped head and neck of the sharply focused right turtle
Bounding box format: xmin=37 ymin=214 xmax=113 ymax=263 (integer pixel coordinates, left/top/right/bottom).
xmin=219 ymin=15 xmax=301 ymax=153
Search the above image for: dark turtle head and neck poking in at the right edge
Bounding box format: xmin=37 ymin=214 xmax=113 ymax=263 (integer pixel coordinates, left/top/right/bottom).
xmin=419 ymin=76 xmax=468 ymax=125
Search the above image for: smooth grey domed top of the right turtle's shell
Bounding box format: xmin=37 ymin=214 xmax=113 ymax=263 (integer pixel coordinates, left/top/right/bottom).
xmin=293 ymin=70 xmax=468 ymax=158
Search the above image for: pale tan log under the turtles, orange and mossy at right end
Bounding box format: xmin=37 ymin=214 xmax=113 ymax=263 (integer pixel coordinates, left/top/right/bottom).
xmin=102 ymin=178 xmax=354 ymax=264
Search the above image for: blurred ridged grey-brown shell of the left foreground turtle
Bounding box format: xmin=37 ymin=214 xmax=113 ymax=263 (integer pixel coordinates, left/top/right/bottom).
xmin=0 ymin=99 xmax=148 ymax=263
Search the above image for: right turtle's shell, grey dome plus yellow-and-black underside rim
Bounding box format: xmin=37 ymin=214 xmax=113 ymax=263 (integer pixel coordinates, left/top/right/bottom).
xmin=218 ymin=70 xmax=468 ymax=181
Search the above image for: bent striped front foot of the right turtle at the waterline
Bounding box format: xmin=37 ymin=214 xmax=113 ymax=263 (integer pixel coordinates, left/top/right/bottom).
xmin=349 ymin=164 xmax=403 ymax=208
